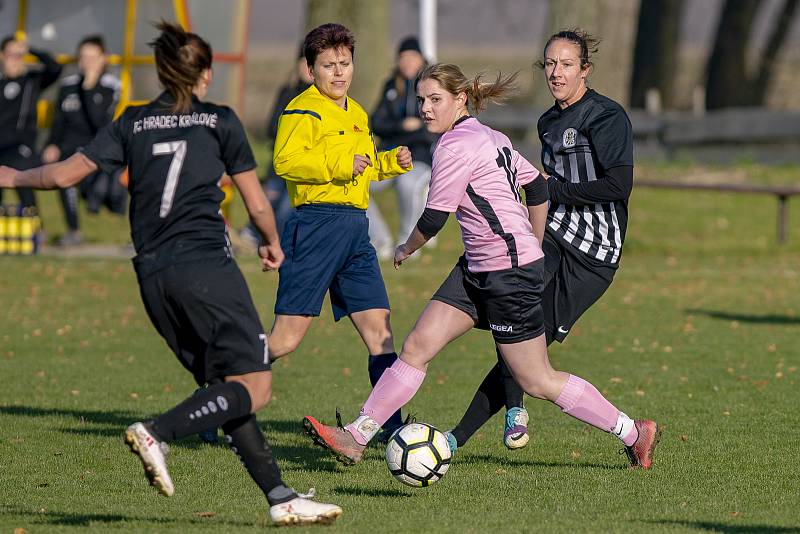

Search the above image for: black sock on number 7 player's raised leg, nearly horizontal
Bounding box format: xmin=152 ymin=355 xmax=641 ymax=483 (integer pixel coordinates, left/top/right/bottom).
xmin=148 ymin=382 xmax=251 ymax=442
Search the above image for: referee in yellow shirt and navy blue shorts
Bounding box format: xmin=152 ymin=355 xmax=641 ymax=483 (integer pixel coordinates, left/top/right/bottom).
xmin=269 ymin=24 xmax=412 ymax=435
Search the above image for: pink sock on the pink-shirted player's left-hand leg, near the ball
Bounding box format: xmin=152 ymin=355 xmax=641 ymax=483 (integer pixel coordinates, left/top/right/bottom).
xmin=345 ymin=359 xmax=425 ymax=445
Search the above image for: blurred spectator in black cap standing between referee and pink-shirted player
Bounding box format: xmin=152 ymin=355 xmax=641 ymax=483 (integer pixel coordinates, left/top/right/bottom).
xmin=367 ymin=37 xmax=436 ymax=259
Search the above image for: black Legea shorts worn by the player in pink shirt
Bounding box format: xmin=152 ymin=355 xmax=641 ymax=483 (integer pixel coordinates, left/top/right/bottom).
xmin=431 ymin=256 xmax=544 ymax=344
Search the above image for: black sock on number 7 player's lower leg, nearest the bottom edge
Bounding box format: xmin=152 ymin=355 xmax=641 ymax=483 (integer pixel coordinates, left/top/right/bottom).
xmin=222 ymin=414 xmax=297 ymax=506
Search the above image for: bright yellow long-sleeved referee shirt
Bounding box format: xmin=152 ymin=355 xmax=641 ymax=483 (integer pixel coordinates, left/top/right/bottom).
xmin=273 ymin=85 xmax=411 ymax=209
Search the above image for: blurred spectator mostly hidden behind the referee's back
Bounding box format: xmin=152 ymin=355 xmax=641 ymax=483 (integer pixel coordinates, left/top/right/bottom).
xmin=239 ymin=43 xmax=311 ymax=245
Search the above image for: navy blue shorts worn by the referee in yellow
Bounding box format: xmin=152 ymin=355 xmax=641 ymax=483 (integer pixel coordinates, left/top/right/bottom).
xmin=275 ymin=204 xmax=389 ymax=321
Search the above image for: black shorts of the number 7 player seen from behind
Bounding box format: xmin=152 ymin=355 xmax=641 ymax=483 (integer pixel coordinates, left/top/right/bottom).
xmin=139 ymin=256 xmax=270 ymax=385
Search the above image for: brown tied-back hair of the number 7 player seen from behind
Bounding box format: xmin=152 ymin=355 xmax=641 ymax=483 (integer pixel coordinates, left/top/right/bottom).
xmin=149 ymin=20 xmax=212 ymax=113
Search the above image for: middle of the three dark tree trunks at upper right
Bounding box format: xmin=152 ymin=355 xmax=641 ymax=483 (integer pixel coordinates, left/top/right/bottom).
xmin=706 ymin=0 xmax=760 ymax=109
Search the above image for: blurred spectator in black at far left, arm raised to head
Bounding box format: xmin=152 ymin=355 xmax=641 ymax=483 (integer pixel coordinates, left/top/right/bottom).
xmin=0 ymin=37 xmax=61 ymax=208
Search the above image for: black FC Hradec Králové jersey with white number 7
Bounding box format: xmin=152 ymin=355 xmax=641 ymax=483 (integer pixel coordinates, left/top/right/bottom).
xmin=83 ymin=92 xmax=256 ymax=275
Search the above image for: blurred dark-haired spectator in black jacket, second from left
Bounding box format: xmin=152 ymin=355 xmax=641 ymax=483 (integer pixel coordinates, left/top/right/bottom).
xmin=42 ymin=35 xmax=121 ymax=246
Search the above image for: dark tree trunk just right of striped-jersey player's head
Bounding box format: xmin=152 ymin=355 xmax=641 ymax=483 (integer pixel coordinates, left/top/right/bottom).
xmin=630 ymin=0 xmax=684 ymax=108
